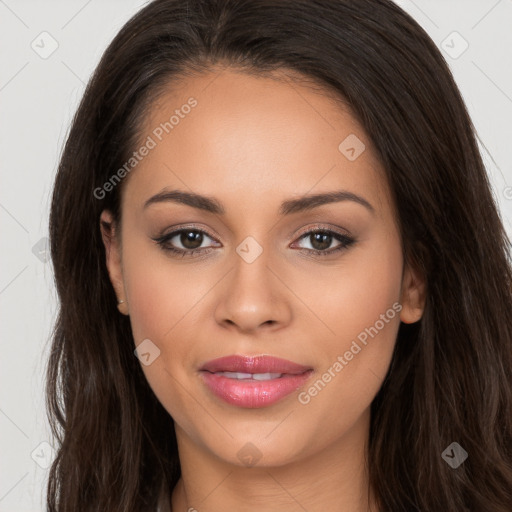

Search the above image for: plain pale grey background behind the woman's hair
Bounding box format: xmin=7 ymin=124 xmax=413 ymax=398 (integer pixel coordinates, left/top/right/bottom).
xmin=0 ymin=0 xmax=512 ymax=512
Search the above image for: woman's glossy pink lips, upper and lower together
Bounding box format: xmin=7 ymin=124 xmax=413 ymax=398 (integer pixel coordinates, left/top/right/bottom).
xmin=200 ymin=355 xmax=313 ymax=409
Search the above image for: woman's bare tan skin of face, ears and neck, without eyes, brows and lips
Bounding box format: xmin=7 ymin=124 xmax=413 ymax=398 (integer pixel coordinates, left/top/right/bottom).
xmin=101 ymin=68 xmax=425 ymax=512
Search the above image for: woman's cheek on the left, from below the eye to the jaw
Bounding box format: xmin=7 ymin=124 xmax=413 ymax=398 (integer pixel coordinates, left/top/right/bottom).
xmin=123 ymin=240 xmax=207 ymax=425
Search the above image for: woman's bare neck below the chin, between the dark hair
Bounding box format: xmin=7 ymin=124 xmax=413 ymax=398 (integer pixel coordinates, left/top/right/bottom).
xmin=172 ymin=411 xmax=377 ymax=512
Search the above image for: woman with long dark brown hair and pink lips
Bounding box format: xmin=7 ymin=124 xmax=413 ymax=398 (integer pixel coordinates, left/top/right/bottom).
xmin=47 ymin=0 xmax=512 ymax=512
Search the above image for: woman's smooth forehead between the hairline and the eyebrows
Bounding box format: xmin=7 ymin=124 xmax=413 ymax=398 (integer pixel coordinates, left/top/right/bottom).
xmin=124 ymin=69 xmax=389 ymax=216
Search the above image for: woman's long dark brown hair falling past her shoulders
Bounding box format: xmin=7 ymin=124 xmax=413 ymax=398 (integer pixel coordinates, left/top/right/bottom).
xmin=46 ymin=0 xmax=512 ymax=512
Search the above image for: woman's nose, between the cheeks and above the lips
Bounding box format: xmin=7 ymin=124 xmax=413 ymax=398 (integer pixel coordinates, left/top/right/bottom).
xmin=215 ymin=246 xmax=293 ymax=333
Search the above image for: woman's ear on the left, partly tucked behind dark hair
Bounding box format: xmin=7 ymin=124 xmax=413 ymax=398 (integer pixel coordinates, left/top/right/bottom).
xmin=100 ymin=210 xmax=129 ymax=315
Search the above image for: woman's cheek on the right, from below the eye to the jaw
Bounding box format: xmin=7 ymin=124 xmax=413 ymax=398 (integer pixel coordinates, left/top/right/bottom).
xmin=292 ymin=236 xmax=403 ymax=428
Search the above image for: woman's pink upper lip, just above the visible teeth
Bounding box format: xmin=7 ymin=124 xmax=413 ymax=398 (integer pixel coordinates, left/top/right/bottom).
xmin=200 ymin=355 xmax=312 ymax=375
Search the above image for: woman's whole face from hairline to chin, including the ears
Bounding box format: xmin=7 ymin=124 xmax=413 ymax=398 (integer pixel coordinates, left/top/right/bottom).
xmin=102 ymin=70 xmax=423 ymax=466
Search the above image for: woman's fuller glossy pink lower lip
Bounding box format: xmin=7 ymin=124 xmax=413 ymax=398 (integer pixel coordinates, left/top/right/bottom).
xmin=201 ymin=370 xmax=313 ymax=409
